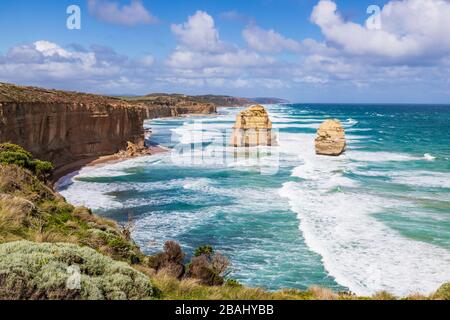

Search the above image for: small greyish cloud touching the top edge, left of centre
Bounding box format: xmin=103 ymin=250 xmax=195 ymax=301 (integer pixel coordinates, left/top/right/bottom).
xmin=88 ymin=0 xmax=158 ymax=27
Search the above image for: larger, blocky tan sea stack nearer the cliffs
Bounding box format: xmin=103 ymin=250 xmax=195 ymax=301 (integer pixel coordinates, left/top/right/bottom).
xmin=231 ymin=105 xmax=276 ymax=147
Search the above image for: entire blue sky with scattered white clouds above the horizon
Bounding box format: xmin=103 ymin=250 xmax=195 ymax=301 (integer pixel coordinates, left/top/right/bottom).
xmin=0 ymin=0 xmax=450 ymax=103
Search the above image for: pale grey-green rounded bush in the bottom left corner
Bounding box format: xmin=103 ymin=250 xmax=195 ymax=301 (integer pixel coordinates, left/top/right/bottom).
xmin=0 ymin=241 xmax=154 ymax=300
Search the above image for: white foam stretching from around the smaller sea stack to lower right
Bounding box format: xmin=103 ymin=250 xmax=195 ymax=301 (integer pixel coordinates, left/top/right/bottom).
xmin=279 ymin=131 xmax=450 ymax=295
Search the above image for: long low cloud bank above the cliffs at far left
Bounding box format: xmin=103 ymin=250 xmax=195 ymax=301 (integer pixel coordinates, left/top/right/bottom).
xmin=0 ymin=40 xmax=154 ymax=92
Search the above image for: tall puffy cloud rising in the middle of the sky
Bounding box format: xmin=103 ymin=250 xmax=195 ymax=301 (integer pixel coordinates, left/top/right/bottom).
xmin=158 ymin=11 xmax=290 ymax=89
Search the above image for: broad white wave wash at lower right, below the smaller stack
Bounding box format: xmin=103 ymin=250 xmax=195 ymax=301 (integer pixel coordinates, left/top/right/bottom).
xmin=280 ymin=182 xmax=450 ymax=295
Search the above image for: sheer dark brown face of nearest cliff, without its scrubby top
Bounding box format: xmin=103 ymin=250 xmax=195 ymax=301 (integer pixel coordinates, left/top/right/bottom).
xmin=0 ymin=102 xmax=144 ymax=168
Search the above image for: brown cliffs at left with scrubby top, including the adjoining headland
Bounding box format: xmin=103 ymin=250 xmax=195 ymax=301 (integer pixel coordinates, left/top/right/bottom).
xmin=0 ymin=83 xmax=215 ymax=176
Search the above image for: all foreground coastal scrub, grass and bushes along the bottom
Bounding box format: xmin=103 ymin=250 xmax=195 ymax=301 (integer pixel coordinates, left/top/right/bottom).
xmin=0 ymin=144 xmax=450 ymax=300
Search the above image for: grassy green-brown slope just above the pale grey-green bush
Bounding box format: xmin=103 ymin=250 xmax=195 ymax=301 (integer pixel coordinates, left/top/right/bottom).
xmin=0 ymin=165 xmax=144 ymax=264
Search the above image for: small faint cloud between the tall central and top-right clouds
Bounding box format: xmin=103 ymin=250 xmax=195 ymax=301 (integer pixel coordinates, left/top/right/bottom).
xmin=242 ymin=25 xmax=301 ymax=52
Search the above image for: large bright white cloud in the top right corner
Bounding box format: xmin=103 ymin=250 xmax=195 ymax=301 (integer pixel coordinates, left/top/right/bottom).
xmin=311 ymin=0 xmax=450 ymax=61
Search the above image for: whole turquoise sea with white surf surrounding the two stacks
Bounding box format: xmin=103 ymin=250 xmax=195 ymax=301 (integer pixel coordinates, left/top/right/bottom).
xmin=61 ymin=104 xmax=450 ymax=294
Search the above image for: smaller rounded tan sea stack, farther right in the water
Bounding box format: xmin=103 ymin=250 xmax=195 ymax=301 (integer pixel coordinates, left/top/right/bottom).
xmin=316 ymin=120 xmax=347 ymax=156
